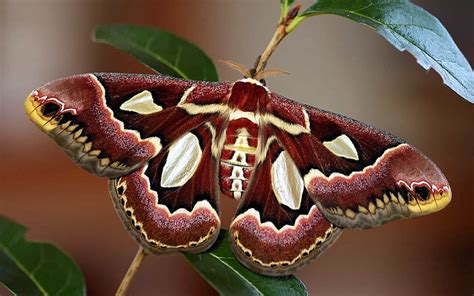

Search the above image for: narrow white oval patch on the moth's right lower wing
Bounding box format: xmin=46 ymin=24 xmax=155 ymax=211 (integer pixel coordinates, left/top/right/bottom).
xmin=271 ymin=151 xmax=304 ymax=210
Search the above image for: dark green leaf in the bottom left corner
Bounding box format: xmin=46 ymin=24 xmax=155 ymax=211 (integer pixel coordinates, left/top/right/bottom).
xmin=0 ymin=216 xmax=86 ymax=295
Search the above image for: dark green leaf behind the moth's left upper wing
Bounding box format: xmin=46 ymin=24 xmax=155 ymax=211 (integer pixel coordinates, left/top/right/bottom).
xmin=92 ymin=25 xmax=218 ymax=81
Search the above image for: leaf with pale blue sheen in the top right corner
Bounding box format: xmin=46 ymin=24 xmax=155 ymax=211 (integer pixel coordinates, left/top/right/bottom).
xmin=296 ymin=0 xmax=474 ymax=102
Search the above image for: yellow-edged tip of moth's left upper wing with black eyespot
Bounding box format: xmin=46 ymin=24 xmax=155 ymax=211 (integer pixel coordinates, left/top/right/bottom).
xmin=24 ymin=74 xmax=103 ymax=133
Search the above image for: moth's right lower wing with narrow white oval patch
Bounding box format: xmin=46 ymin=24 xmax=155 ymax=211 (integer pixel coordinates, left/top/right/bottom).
xmin=230 ymin=126 xmax=341 ymax=275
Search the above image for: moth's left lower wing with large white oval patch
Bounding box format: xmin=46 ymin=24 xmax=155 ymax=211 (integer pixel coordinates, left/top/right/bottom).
xmin=109 ymin=121 xmax=225 ymax=253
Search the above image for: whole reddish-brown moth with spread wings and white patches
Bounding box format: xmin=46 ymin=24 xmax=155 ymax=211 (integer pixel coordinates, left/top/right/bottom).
xmin=25 ymin=73 xmax=451 ymax=276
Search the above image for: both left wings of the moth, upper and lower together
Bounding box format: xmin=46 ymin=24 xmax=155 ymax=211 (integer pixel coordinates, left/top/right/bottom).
xmin=25 ymin=73 xmax=229 ymax=253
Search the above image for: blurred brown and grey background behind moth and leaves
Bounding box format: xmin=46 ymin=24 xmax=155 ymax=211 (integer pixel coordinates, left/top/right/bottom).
xmin=0 ymin=0 xmax=474 ymax=295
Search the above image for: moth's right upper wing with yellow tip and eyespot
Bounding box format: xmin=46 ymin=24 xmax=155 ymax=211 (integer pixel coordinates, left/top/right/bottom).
xmin=269 ymin=94 xmax=451 ymax=228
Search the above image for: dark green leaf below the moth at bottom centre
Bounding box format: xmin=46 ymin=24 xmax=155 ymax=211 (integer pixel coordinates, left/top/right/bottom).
xmin=184 ymin=230 xmax=308 ymax=296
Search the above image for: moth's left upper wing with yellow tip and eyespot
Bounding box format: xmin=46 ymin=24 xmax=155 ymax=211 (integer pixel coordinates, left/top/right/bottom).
xmin=25 ymin=73 xmax=229 ymax=178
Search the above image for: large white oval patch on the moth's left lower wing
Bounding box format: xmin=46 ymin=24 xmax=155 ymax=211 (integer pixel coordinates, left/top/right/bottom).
xmin=161 ymin=133 xmax=202 ymax=188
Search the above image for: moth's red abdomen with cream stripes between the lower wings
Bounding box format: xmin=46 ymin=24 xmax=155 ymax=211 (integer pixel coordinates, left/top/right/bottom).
xmin=219 ymin=114 xmax=258 ymax=199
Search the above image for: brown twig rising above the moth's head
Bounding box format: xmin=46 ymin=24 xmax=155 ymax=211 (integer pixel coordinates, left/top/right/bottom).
xmin=250 ymin=5 xmax=301 ymax=78
